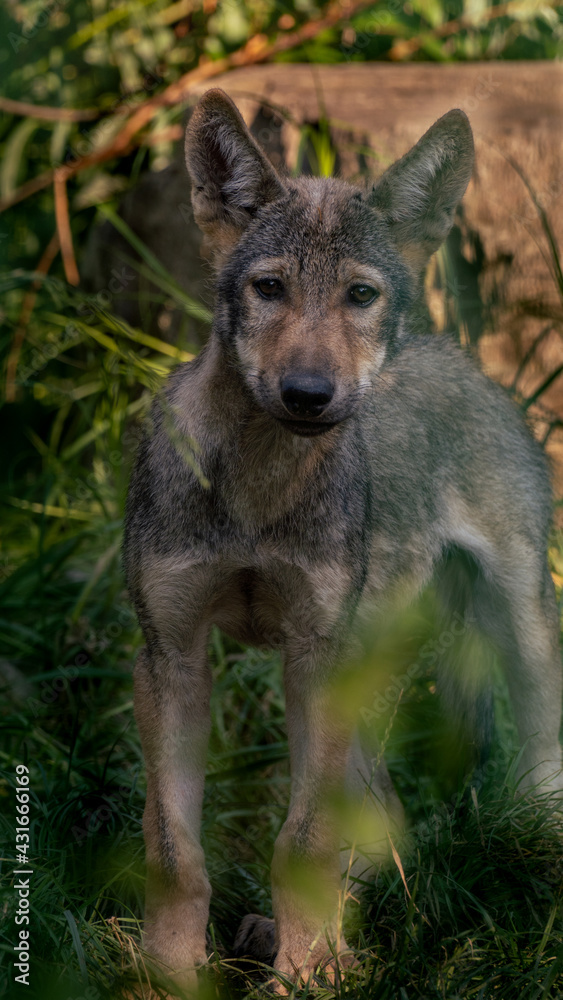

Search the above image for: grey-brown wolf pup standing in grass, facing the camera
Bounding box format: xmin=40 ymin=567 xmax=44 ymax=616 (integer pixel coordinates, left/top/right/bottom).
xmin=125 ymin=90 xmax=563 ymax=989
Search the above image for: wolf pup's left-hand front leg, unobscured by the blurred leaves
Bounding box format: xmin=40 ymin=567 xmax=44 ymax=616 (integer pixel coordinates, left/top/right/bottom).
xmin=134 ymin=637 xmax=211 ymax=990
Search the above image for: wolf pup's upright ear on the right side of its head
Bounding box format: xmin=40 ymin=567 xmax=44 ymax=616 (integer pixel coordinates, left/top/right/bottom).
xmin=368 ymin=110 xmax=474 ymax=270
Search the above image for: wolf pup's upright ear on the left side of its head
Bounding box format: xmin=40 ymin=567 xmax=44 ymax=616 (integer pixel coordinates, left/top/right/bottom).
xmin=185 ymin=90 xmax=284 ymax=264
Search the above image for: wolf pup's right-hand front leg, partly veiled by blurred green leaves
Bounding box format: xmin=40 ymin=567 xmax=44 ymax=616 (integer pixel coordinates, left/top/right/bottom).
xmin=272 ymin=659 xmax=360 ymax=992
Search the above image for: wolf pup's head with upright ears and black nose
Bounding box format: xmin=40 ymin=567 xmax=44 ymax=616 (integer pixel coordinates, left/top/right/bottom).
xmin=186 ymin=90 xmax=473 ymax=436
